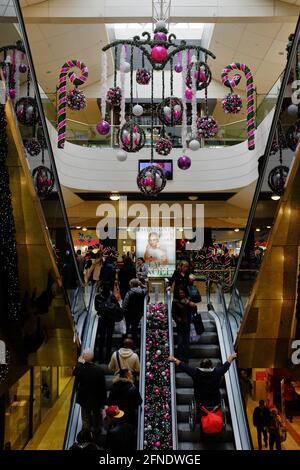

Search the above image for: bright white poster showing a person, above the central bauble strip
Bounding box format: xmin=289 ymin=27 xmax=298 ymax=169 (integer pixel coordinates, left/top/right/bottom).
xmin=136 ymin=227 xmax=176 ymax=277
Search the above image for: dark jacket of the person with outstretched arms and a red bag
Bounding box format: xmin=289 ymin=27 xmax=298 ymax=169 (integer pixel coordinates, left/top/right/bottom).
xmin=179 ymin=361 xmax=230 ymax=406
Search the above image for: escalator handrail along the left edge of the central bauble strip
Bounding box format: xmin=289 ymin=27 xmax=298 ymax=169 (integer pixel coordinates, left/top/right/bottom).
xmin=137 ymin=295 xmax=148 ymax=450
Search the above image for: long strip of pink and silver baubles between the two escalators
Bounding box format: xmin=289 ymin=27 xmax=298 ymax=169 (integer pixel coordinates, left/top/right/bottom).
xmin=144 ymin=304 xmax=172 ymax=450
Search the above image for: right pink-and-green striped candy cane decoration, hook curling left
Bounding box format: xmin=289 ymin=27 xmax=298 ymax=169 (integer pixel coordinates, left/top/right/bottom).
xmin=221 ymin=63 xmax=255 ymax=150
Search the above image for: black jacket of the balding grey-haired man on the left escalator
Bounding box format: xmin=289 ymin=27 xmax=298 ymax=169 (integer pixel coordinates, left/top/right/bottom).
xmin=73 ymin=362 xmax=106 ymax=410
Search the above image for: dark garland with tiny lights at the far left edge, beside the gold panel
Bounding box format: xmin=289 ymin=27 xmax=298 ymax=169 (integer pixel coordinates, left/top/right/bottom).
xmin=0 ymin=104 xmax=21 ymax=321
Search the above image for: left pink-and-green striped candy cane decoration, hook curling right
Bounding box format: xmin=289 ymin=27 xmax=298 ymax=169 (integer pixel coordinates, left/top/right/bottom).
xmin=57 ymin=59 xmax=89 ymax=149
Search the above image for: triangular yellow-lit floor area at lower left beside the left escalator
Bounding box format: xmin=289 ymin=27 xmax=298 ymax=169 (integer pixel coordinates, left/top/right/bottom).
xmin=25 ymin=379 xmax=73 ymax=450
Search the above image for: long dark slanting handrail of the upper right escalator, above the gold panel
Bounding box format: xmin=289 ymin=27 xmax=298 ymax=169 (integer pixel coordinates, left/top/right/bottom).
xmin=231 ymin=16 xmax=300 ymax=286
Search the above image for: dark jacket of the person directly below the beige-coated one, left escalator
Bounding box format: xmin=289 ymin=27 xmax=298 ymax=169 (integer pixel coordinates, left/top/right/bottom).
xmin=108 ymin=379 xmax=143 ymax=423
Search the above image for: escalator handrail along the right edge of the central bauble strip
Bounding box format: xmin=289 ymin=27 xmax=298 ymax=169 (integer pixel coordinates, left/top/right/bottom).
xmin=166 ymin=289 xmax=178 ymax=450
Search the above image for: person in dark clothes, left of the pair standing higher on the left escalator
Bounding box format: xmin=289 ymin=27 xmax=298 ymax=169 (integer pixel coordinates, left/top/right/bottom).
xmin=94 ymin=282 xmax=123 ymax=363
